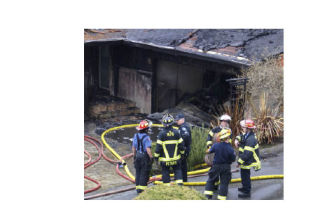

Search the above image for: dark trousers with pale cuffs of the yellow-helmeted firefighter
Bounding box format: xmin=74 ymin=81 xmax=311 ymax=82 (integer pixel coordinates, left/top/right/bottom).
xmin=204 ymin=164 xmax=231 ymax=199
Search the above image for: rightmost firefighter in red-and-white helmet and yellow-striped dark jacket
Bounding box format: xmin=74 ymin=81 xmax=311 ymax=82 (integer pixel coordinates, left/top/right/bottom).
xmin=237 ymin=120 xmax=261 ymax=198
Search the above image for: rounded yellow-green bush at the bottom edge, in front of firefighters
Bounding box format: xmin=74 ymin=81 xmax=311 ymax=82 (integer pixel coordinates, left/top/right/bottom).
xmin=134 ymin=185 xmax=206 ymax=200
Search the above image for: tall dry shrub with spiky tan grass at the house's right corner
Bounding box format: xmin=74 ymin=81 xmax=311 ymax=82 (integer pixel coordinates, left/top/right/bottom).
xmin=241 ymin=57 xmax=284 ymax=144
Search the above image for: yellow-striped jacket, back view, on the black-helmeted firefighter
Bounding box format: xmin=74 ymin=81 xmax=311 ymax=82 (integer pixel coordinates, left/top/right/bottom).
xmin=154 ymin=126 xmax=185 ymax=164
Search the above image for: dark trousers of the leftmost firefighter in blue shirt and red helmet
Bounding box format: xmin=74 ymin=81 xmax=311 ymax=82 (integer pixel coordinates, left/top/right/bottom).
xmin=134 ymin=153 xmax=152 ymax=193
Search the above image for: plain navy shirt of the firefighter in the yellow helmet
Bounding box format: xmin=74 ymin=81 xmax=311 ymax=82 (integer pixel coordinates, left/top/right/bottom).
xmin=209 ymin=142 xmax=236 ymax=165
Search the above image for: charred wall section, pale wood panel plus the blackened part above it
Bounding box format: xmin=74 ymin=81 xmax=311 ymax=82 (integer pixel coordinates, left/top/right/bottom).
xmin=110 ymin=45 xmax=154 ymax=113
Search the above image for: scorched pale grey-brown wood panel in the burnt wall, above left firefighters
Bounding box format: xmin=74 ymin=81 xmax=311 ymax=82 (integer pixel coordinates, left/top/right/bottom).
xmin=117 ymin=67 xmax=152 ymax=114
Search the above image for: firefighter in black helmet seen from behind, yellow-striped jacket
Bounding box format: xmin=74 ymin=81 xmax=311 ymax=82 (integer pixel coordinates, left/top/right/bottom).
xmin=154 ymin=114 xmax=185 ymax=185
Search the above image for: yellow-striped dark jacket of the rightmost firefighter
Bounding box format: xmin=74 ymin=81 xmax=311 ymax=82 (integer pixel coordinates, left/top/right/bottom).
xmin=238 ymin=132 xmax=261 ymax=170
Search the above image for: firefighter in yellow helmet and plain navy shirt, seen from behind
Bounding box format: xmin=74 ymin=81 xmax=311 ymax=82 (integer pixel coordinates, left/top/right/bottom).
xmin=204 ymin=129 xmax=236 ymax=200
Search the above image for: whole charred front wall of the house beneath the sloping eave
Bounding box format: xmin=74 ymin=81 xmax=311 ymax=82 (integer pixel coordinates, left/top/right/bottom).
xmin=85 ymin=43 xmax=240 ymax=118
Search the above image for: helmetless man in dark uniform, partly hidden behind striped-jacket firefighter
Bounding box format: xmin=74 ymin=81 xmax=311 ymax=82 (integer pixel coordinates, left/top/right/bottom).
xmin=176 ymin=113 xmax=191 ymax=182
